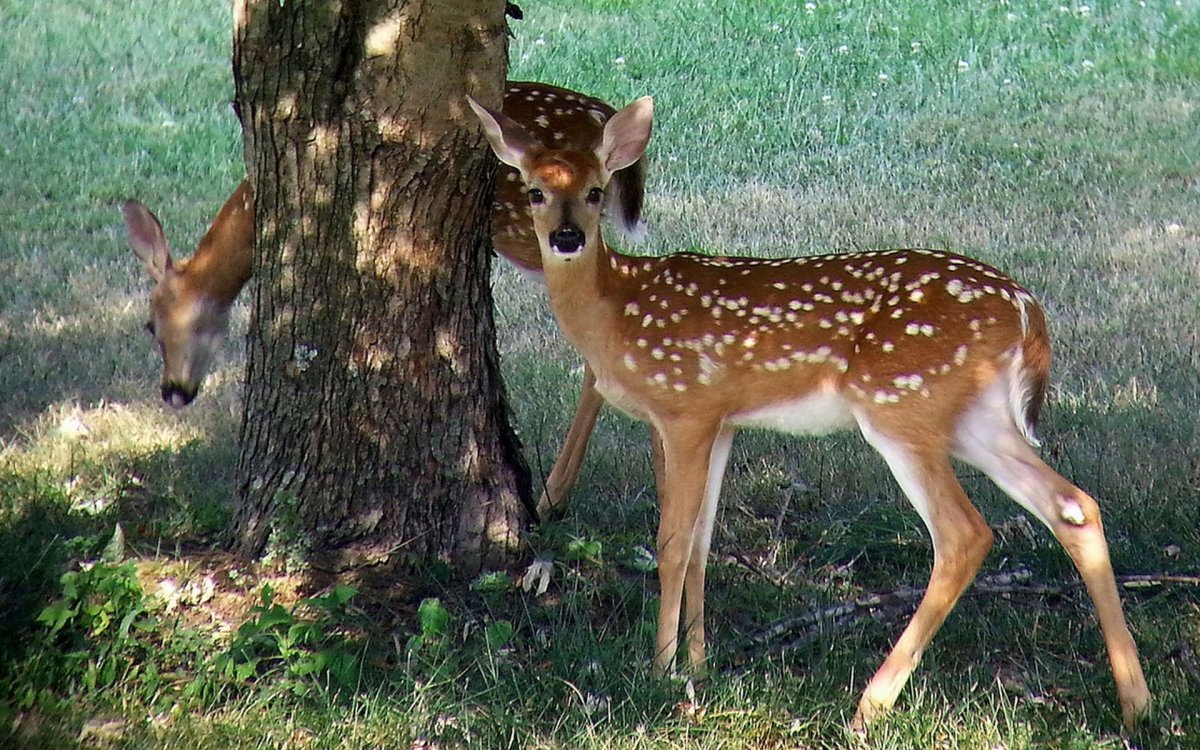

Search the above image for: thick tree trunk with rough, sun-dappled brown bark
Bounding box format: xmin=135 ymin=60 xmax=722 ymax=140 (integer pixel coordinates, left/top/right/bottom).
xmin=234 ymin=0 xmax=530 ymax=575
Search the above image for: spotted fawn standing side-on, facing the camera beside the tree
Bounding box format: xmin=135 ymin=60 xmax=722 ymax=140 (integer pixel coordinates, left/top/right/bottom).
xmin=470 ymin=92 xmax=1150 ymax=726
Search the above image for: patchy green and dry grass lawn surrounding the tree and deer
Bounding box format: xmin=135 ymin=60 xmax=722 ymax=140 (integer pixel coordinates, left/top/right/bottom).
xmin=0 ymin=0 xmax=1200 ymax=749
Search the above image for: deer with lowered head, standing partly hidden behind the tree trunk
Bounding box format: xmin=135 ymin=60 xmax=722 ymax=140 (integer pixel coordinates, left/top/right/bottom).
xmin=121 ymin=82 xmax=644 ymax=514
